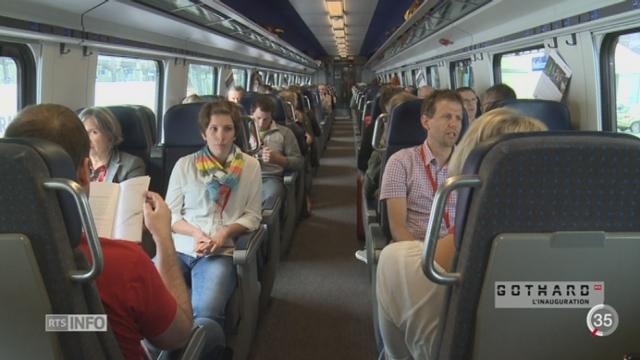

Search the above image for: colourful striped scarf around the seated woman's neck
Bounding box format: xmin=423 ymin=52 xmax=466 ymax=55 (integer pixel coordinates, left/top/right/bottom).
xmin=196 ymin=145 xmax=244 ymax=212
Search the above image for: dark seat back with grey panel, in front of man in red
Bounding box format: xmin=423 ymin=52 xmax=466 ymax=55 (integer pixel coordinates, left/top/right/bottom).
xmin=0 ymin=138 xmax=203 ymax=359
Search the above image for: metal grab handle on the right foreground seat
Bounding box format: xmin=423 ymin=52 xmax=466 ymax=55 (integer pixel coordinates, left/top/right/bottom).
xmin=421 ymin=175 xmax=481 ymax=285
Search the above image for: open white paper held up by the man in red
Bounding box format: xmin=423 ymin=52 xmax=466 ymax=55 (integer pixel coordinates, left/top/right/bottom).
xmin=89 ymin=176 xmax=150 ymax=242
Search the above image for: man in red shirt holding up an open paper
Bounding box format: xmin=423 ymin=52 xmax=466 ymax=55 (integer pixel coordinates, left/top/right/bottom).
xmin=5 ymin=104 xmax=193 ymax=359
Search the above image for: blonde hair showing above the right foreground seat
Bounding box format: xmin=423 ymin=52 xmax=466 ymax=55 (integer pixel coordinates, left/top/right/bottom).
xmin=449 ymin=108 xmax=547 ymax=176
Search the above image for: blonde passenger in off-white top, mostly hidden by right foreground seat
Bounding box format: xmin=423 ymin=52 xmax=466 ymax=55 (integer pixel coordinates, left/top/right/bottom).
xmin=376 ymin=109 xmax=546 ymax=360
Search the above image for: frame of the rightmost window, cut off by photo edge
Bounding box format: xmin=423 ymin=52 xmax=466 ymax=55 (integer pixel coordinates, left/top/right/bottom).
xmin=599 ymin=27 xmax=640 ymax=132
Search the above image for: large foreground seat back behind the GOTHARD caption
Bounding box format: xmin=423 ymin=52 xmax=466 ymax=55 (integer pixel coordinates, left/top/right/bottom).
xmin=422 ymin=132 xmax=640 ymax=360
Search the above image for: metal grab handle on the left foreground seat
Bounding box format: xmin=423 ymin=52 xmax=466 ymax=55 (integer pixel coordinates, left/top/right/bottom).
xmin=44 ymin=178 xmax=104 ymax=282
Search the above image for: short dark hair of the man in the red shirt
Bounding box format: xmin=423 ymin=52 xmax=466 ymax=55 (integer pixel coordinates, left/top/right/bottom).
xmin=4 ymin=104 xmax=91 ymax=169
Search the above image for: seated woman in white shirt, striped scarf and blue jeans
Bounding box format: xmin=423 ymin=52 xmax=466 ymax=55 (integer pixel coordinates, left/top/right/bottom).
xmin=166 ymin=100 xmax=262 ymax=359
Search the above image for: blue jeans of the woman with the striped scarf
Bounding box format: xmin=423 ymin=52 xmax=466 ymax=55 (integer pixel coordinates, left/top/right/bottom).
xmin=178 ymin=253 xmax=237 ymax=359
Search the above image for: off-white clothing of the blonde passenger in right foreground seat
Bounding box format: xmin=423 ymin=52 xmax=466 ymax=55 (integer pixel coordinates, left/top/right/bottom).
xmin=376 ymin=241 xmax=446 ymax=360
